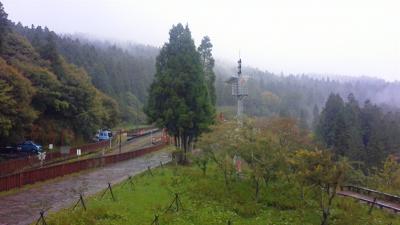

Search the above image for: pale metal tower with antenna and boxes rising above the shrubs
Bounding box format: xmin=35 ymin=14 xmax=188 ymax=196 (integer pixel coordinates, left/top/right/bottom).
xmin=226 ymin=58 xmax=248 ymax=120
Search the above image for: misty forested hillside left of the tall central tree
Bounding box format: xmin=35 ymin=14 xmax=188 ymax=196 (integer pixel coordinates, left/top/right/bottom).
xmin=14 ymin=23 xmax=159 ymax=123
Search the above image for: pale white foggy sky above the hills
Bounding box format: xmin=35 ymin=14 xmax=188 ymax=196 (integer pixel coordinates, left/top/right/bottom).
xmin=0 ymin=0 xmax=400 ymax=80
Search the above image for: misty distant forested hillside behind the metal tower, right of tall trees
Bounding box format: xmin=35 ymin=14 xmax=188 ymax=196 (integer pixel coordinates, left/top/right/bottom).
xmin=215 ymin=65 xmax=400 ymax=128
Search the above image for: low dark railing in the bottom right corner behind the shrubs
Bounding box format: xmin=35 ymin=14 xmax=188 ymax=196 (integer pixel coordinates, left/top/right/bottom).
xmin=340 ymin=185 xmax=400 ymax=213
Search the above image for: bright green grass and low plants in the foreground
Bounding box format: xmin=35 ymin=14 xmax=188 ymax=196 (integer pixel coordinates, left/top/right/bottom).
xmin=46 ymin=165 xmax=400 ymax=225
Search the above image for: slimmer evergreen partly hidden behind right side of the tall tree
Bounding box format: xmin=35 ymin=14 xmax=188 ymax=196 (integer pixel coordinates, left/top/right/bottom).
xmin=197 ymin=36 xmax=217 ymax=106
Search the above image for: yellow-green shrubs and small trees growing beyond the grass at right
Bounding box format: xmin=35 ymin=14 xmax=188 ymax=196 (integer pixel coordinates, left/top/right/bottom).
xmin=196 ymin=118 xmax=400 ymax=225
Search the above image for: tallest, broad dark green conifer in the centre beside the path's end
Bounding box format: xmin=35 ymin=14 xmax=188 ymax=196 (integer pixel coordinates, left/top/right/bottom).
xmin=145 ymin=23 xmax=214 ymax=161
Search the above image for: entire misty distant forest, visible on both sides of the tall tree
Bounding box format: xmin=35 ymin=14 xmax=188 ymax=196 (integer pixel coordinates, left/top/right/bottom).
xmin=3 ymin=20 xmax=400 ymax=143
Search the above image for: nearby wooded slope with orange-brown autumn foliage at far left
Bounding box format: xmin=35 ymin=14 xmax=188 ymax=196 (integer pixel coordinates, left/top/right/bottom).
xmin=0 ymin=5 xmax=119 ymax=144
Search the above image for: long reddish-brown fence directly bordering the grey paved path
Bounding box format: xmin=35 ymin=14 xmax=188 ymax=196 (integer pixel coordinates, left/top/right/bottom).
xmin=0 ymin=144 xmax=165 ymax=191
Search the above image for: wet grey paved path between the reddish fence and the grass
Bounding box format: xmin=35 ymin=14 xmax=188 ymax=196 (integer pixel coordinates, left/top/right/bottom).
xmin=0 ymin=151 xmax=170 ymax=225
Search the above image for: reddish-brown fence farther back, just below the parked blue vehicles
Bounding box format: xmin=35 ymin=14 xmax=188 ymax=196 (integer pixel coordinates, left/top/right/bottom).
xmin=0 ymin=141 xmax=109 ymax=176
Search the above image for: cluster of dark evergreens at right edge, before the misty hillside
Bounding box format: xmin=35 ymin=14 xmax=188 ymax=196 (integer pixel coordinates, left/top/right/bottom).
xmin=316 ymin=94 xmax=400 ymax=169
